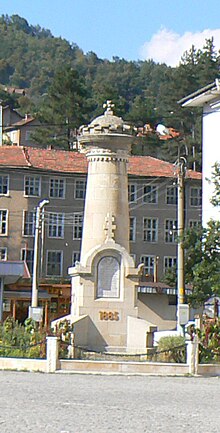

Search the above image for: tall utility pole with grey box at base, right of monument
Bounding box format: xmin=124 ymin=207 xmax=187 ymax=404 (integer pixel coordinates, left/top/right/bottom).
xmin=177 ymin=157 xmax=189 ymax=333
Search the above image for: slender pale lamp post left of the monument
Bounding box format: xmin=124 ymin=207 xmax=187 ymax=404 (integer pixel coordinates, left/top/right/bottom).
xmin=29 ymin=199 xmax=49 ymax=318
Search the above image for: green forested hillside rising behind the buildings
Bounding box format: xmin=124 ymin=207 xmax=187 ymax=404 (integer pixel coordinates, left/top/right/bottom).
xmin=0 ymin=15 xmax=220 ymax=168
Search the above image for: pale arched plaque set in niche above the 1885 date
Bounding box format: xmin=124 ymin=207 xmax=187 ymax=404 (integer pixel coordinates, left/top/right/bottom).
xmin=97 ymin=256 xmax=120 ymax=298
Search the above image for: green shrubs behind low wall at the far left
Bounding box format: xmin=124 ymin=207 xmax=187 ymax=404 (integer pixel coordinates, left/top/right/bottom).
xmin=0 ymin=316 xmax=46 ymax=358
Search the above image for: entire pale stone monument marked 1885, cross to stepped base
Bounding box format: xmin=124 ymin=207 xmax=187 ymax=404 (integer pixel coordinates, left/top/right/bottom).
xmin=69 ymin=101 xmax=155 ymax=351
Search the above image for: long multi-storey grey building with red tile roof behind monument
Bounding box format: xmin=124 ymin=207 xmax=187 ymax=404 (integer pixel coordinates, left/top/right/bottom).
xmin=0 ymin=146 xmax=202 ymax=322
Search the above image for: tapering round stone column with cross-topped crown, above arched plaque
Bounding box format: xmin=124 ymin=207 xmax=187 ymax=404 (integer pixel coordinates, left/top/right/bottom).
xmin=78 ymin=101 xmax=133 ymax=262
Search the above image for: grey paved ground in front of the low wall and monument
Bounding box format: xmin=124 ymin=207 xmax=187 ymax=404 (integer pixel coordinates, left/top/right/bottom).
xmin=0 ymin=371 xmax=220 ymax=433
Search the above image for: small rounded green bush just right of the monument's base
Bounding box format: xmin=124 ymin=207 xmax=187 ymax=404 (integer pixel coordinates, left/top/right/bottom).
xmin=157 ymin=335 xmax=185 ymax=362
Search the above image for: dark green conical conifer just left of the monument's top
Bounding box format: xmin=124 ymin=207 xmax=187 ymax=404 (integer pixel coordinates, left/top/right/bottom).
xmin=33 ymin=66 xmax=88 ymax=149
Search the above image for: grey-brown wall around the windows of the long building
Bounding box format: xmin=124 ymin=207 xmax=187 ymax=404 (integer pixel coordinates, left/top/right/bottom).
xmin=0 ymin=167 xmax=201 ymax=280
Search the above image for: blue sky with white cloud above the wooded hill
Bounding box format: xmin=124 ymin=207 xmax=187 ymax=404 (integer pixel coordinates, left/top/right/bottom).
xmin=0 ymin=0 xmax=220 ymax=66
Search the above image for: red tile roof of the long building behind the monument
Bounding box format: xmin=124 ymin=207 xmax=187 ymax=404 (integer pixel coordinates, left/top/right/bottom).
xmin=0 ymin=146 xmax=202 ymax=179
